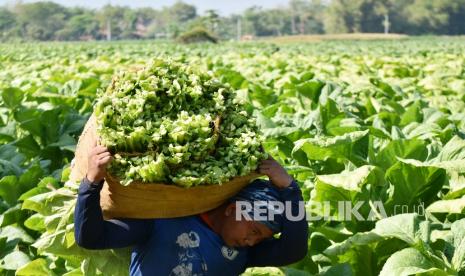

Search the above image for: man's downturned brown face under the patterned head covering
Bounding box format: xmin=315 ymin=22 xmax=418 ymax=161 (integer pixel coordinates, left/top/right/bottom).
xmin=220 ymin=203 xmax=273 ymax=247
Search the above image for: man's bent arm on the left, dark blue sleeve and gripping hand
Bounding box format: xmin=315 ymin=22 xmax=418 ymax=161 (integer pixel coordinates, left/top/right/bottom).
xmin=74 ymin=144 xmax=153 ymax=249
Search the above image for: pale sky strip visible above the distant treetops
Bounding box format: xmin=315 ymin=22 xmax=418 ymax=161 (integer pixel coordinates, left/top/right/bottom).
xmin=4 ymin=0 xmax=288 ymax=15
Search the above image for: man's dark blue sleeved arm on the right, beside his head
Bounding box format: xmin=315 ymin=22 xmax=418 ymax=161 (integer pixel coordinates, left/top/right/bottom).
xmin=246 ymin=181 xmax=308 ymax=267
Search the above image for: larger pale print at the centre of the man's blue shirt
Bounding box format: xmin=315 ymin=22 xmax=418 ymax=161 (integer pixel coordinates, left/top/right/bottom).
xmin=170 ymin=231 xmax=207 ymax=276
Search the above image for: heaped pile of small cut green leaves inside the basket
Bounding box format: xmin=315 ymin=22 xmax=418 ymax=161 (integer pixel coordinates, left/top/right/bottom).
xmin=95 ymin=59 xmax=266 ymax=187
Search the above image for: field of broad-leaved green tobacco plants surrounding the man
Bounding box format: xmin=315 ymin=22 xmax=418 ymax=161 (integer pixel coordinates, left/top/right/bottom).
xmin=0 ymin=37 xmax=465 ymax=276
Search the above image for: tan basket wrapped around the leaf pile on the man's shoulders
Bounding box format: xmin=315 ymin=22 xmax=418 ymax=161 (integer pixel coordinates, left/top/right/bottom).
xmin=70 ymin=115 xmax=260 ymax=219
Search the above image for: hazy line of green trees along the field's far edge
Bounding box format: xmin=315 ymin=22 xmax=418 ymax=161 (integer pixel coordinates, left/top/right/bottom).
xmin=0 ymin=0 xmax=465 ymax=41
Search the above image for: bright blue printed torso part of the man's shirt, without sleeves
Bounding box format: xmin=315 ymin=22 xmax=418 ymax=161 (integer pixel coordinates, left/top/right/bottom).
xmin=130 ymin=216 xmax=247 ymax=275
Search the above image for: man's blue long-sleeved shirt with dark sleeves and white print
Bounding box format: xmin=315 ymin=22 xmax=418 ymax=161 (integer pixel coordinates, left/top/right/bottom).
xmin=74 ymin=178 xmax=308 ymax=276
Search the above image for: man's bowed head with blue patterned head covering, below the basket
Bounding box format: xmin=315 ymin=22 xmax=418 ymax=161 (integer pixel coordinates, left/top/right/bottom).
xmin=209 ymin=180 xmax=283 ymax=247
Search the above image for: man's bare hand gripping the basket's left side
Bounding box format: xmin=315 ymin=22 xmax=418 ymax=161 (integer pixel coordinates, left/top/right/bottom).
xmin=86 ymin=143 xmax=113 ymax=183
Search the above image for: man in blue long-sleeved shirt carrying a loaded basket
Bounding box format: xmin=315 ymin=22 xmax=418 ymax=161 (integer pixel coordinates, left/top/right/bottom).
xmin=74 ymin=145 xmax=308 ymax=276
